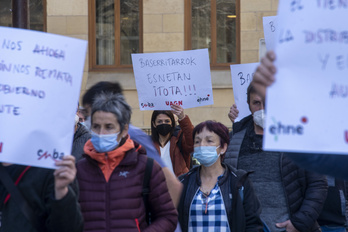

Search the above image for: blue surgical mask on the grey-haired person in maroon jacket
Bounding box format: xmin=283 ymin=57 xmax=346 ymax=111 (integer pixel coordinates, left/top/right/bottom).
xmin=91 ymin=131 xmax=120 ymax=152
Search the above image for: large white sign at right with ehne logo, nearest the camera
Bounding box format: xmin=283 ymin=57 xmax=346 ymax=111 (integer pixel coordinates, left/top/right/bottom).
xmin=264 ymin=0 xmax=348 ymax=154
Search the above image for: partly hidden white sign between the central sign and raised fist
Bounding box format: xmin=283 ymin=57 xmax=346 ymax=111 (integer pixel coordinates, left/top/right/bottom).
xmin=230 ymin=63 xmax=259 ymax=122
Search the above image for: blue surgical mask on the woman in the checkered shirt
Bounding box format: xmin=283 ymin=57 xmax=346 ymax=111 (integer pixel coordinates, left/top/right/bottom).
xmin=193 ymin=146 xmax=220 ymax=167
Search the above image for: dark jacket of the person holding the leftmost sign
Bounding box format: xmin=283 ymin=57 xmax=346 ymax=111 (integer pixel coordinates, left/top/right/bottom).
xmin=0 ymin=165 xmax=83 ymax=232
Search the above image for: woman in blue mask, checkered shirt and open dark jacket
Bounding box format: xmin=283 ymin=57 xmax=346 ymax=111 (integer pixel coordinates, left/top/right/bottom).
xmin=178 ymin=121 xmax=263 ymax=232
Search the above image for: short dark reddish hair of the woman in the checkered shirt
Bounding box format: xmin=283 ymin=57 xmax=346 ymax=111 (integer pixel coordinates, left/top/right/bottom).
xmin=192 ymin=120 xmax=230 ymax=161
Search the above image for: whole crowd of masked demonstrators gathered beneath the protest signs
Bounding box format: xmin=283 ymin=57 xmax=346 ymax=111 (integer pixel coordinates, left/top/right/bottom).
xmin=0 ymin=59 xmax=348 ymax=232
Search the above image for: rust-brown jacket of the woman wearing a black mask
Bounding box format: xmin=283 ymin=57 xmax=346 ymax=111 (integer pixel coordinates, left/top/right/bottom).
xmin=155 ymin=115 xmax=193 ymax=176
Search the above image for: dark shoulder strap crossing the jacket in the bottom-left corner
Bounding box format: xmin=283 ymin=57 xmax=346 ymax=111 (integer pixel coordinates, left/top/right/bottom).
xmin=0 ymin=163 xmax=44 ymax=231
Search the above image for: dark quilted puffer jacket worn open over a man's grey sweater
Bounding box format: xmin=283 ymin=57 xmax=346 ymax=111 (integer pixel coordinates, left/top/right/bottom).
xmin=224 ymin=116 xmax=327 ymax=231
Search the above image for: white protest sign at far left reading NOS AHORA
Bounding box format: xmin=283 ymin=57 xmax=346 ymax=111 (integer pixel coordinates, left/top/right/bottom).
xmin=0 ymin=27 xmax=87 ymax=168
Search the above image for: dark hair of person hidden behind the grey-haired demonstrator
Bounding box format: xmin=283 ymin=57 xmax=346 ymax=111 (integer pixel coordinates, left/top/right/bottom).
xmin=82 ymin=81 xmax=123 ymax=106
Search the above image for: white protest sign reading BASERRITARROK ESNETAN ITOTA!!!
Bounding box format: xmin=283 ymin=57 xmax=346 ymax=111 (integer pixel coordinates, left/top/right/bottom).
xmin=132 ymin=49 xmax=214 ymax=110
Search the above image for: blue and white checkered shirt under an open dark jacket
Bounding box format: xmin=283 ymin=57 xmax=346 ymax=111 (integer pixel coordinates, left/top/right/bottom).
xmin=188 ymin=175 xmax=230 ymax=232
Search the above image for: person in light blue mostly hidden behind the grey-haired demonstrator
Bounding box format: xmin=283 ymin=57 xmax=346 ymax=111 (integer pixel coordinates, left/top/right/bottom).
xmin=82 ymin=81 xmax=182 ymax=206
